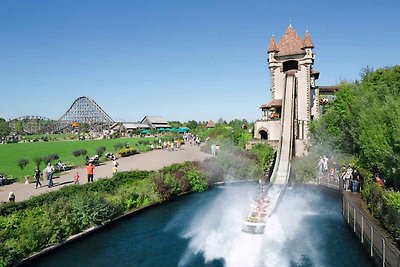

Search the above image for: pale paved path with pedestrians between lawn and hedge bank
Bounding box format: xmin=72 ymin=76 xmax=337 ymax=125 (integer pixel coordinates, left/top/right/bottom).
xmin=0 ymin=145 xmax=209 ymax=204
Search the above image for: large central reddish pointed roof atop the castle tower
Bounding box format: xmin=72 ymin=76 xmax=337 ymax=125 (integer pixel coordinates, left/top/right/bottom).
xmin=276 ymin=24 xmax=305 ymax=56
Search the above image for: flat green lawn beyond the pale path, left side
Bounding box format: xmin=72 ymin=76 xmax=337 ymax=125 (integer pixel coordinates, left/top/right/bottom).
xmin=0 ymin=138 xmax=154 ymax=179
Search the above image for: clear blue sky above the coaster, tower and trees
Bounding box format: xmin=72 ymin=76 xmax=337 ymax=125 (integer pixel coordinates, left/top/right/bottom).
xmin=0 ymin=0 xmax=400 ymax=122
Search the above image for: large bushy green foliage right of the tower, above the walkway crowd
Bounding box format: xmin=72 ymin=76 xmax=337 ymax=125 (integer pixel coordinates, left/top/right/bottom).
xmin=311 ymin=66 xmax=400 ymax=187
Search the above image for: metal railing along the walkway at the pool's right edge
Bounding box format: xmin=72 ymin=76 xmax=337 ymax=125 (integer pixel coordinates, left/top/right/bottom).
xmin=342 ymin=194 xmax=400 ymax=267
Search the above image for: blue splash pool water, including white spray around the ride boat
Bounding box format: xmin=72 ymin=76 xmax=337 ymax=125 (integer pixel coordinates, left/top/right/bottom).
xmin=26 ymin=184 xmax=373 ymax=267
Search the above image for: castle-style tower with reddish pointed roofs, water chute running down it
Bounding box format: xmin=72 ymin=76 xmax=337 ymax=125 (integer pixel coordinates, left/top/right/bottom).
xmin=254 ymin=25 xmax=319 ymax=156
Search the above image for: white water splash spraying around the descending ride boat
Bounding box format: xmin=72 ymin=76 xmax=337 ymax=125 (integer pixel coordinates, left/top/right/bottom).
xmin=179 ymin=188 xmax=318 ymax=267
